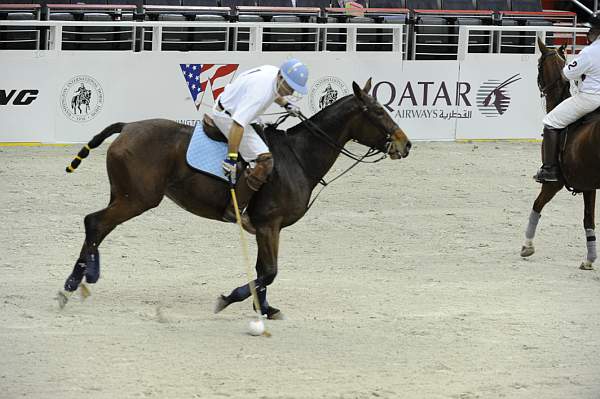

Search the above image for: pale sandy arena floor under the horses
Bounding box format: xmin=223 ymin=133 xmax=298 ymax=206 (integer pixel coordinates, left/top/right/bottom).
xmin=0 ymin=143 xmax=600 ymax=399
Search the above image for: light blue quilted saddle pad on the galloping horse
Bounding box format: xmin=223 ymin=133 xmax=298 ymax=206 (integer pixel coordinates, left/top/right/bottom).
xmin=186 ymin=123 xmax=228 ymax=181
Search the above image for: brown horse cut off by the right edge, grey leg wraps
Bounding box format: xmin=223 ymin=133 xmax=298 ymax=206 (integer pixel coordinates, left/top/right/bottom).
xmin=521 ymin=39 xmax=600 ymax=270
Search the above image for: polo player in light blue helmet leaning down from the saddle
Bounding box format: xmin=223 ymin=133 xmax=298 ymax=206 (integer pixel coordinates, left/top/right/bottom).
xmin=213 ymin=58 xmax=308 ymax=233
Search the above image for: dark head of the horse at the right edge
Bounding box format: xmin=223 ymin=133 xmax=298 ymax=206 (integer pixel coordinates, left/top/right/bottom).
xmin=537 ymin=37 xmax=569 ymax=109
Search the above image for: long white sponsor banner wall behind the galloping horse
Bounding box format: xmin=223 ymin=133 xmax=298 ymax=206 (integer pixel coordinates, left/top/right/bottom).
xmin=0 ymin=51 xmax=543 ymax=143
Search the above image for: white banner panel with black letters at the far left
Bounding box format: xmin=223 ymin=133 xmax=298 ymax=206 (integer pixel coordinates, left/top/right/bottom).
xmin=0 ymin=51 xmax=56 ymax=142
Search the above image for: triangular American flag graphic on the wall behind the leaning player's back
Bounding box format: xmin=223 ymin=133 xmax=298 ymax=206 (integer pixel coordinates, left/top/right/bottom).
xmin=179 ymin=64 xmax=239 ymax=109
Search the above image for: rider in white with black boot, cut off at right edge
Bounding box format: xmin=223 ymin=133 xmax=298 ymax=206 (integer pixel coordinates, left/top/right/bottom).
xmin=534 ymin=11 xmax=600 ymax=183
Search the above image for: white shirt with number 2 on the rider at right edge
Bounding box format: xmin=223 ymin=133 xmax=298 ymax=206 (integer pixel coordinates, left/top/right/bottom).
xmin=563 ymin=39 xmax=600 ymax=94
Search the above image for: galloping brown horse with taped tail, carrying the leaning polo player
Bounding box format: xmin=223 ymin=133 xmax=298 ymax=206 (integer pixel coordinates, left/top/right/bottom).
xmin=58 ymin=79 xmax=411 ymax=319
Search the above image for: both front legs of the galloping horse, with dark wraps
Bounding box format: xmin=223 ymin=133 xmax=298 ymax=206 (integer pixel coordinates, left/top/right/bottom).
xmin=215 ymin=225 xmax=283 ymax=319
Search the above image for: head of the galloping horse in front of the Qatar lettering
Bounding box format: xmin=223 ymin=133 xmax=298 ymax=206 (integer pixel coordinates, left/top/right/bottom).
xmin=352 ymin=79 xmax=412 ymax=159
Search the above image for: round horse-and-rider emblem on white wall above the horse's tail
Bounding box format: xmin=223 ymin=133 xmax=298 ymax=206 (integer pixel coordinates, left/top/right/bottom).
xmin=60 ymin=75 xmax=104 ymax=122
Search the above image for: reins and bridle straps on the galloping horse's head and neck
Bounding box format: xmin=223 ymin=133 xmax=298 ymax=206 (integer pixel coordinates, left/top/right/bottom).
xmin=274 ymin=105 xmax=392 ymax=211
